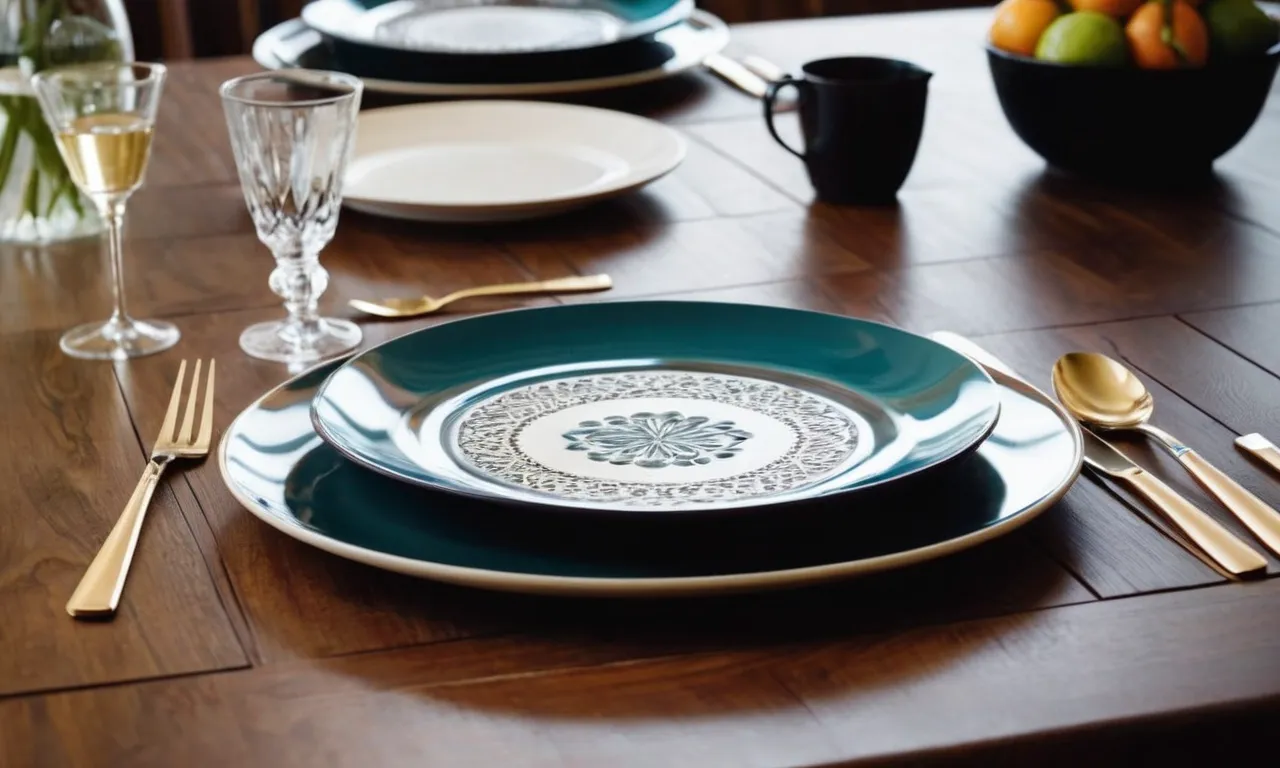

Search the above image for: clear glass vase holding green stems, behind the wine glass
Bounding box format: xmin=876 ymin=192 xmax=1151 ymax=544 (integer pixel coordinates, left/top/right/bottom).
xmin=0 ymin=0 xmax=133 ymax=244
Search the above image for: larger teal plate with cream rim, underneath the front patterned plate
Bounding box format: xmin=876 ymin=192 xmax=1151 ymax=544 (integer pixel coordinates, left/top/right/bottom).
xmin=218 ymin=362 xmax=1082 ymax=596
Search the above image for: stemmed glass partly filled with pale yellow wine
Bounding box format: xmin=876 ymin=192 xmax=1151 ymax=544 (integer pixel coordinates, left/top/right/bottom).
xmin=31 ymin=61 xmax=179 ymax=360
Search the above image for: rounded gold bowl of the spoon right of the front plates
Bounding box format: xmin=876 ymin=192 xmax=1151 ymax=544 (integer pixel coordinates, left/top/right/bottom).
xmin=1053 ymin=352 xmax=1156 ymax=429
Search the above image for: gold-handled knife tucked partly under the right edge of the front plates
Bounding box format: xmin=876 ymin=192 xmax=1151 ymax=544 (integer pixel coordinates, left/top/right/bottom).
xmin=929 ymin=332 xmax=1267 ymax=576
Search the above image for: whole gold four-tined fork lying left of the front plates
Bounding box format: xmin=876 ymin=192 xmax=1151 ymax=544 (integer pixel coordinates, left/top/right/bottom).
xmin=67 ymin=360 xmax=214 ymax=618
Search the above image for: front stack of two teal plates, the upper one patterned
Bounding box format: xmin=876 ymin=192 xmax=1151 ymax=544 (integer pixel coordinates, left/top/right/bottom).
xmin=219 ymin=302 xmax=1080 ymax=596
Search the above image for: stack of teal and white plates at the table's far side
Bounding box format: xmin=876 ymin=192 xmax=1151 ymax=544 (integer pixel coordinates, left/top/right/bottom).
xmin=253 ymin=0 xmax=728 ymax=96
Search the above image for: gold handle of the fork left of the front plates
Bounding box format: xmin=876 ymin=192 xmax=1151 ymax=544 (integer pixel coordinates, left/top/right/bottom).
xmin=67 ymin=458 xmax=165 ymax=618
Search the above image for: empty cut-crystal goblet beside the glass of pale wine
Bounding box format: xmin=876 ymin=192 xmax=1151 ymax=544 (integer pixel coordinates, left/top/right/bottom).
xmin=221 ymin=69 xmax=364 ymax=369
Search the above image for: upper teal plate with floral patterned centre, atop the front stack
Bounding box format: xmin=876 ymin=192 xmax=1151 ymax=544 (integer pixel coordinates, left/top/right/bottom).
xmin=312 ymin=301 xmax=1000 ymax=515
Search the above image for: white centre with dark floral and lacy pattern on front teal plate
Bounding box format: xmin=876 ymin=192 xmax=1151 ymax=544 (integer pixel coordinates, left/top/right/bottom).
xmin=445 ymin=370 xmax=870 ymax=508
